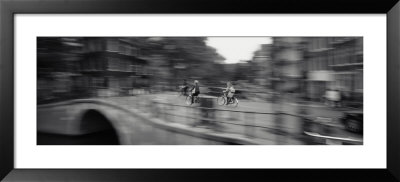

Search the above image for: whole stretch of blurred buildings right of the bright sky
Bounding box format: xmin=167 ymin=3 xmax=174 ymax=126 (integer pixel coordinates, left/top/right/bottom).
xmin=270 ymin=37 xmax=363 ymax=103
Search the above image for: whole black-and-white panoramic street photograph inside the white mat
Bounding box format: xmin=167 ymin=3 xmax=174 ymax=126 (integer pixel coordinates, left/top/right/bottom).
xmin=36 ymin=36 xmax=363 ymax=145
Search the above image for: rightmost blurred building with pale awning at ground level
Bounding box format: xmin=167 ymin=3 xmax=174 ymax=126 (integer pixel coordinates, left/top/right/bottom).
xmin=302 ymin=37 xmax=363 ymax=102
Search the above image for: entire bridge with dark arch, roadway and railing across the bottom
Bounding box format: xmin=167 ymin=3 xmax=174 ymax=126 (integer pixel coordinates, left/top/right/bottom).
xmin=37 ymin=96 xmax=362 ymax=145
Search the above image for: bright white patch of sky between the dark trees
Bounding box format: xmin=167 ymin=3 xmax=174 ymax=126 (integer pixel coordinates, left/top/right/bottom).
xmin=207 ymin=37 xmax=272 ymax=63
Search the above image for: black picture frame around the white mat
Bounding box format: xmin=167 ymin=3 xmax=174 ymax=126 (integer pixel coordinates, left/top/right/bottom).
xmin=0 ymin=0 xmax=400 ymax=182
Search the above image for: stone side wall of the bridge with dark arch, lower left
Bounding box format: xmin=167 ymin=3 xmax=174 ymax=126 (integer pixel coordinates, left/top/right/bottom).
xmin=37 ymin=99 xmax=260 ymax=145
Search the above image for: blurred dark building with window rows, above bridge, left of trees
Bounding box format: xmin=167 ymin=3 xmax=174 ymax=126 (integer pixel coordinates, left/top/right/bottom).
xmin=80 ymin=37 xmax=151 ymax=96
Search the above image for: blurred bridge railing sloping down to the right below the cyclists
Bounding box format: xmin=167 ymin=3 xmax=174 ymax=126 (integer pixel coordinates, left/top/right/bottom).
xmin=139 ymin=97 xmax=362 ymax=144
